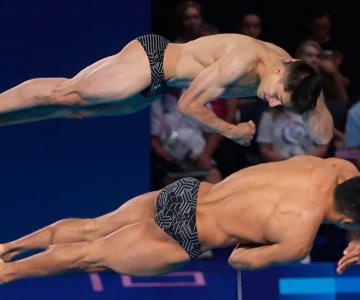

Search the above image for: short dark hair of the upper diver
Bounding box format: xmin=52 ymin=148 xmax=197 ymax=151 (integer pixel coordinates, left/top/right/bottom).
xmin=284 ymin=60 xmax=321 ymax=114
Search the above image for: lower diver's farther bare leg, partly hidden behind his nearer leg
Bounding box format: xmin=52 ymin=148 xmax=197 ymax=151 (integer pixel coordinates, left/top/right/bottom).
xmin=0 ymin=192 xmax=158 ymax=261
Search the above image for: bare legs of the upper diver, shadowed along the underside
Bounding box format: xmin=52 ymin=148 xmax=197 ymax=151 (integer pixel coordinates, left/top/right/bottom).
xmin=0 ymin=41 xmax=151 ymax=125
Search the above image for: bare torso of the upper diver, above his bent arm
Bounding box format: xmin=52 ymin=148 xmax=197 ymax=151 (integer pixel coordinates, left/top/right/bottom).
xmin=164 ymin=33 xmax=291 ymax=96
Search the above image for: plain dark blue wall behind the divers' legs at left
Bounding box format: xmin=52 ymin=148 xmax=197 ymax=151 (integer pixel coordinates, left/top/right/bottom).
xmin=0 ymin=0 xmax=151 ymax=243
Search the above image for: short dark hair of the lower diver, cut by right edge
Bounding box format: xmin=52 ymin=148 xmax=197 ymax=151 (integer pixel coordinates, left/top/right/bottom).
xmin=335 ymin=176 xmax=360 ymax=224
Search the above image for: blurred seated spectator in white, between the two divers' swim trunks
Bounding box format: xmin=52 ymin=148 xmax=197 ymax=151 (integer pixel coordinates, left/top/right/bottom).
xmin=151 ymin=92 xmax=221 ymax=189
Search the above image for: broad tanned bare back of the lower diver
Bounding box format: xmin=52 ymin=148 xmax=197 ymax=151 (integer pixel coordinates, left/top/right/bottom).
xmin=197 ymin=156 xmax=356 ymax=248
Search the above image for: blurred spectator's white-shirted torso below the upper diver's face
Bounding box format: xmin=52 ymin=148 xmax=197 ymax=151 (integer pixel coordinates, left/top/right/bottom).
xmin=257 ymin=107 xmax=327 ymax=161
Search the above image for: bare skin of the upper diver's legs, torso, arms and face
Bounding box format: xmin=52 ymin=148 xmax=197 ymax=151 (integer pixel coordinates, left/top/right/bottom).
xmin=0 ymin=34 xmax=332 ymax=144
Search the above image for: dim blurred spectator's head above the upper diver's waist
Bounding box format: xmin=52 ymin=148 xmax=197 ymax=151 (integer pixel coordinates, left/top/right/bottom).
xmin=175 ymin=1 xmax=204 ymax=43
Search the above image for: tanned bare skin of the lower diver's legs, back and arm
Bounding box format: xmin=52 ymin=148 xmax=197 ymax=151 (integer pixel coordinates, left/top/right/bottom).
xmin=0 ymin=156 xmax=359 ymax=283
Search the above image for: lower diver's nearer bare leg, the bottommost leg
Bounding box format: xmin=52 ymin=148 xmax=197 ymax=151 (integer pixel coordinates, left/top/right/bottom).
xmin=0 ymin=220 xmax=189 ymax=283
